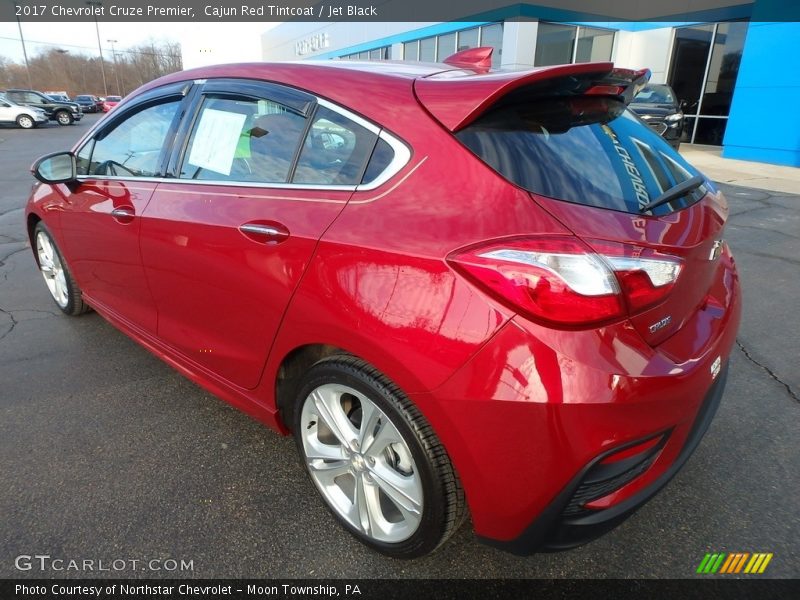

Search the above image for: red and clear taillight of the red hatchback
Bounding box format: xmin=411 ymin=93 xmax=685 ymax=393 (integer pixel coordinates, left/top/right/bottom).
xmin=448 ymin=236 xmax=681 ymax=327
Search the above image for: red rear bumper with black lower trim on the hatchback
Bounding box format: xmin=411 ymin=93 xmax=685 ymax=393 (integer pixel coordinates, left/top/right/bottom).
xmin=412 ymin=255 xmax=741 ymax=554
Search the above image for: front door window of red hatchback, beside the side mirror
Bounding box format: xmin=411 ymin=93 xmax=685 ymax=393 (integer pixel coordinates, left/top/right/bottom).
xmin=89 ymin=99 xmax=181 ymax=177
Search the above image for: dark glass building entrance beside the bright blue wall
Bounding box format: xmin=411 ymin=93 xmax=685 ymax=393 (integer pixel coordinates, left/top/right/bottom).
xmin=668 ymin=21 xmax=748 ymax=146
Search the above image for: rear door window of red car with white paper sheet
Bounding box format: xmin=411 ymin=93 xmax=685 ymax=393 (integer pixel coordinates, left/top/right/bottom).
xmin=180 ymin=95 xmax=306 ymax=183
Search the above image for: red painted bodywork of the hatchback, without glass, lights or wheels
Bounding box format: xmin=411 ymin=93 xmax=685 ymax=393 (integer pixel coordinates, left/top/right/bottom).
xmin=27 ymin=61 xmax=741 ymax=552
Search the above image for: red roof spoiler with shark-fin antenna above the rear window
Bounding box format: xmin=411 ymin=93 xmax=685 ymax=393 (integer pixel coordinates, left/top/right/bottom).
xmin=414 ymin=61 xmax=650 ymax=131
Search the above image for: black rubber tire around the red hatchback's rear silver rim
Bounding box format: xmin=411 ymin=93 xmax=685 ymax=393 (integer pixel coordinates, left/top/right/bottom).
xmin=292 ymin=356 xmax=446 ymax=558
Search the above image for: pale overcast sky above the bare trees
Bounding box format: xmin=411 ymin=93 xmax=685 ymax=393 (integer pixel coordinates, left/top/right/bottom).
xmin=0 ymin=21 xmax=277 ymax=62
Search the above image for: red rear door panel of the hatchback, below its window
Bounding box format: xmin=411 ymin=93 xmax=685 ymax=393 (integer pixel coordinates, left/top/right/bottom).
xmin=141 ymin=183 xmax=351 ymax=389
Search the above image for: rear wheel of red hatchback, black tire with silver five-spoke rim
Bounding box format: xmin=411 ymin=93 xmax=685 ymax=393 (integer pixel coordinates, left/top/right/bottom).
xmin=293 ymin=355 xmax=466 ymax=559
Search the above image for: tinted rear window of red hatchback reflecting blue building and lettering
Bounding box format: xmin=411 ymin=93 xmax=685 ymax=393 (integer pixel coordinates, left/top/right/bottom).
xmin=456 ymin=96 xmax=704 ymax=215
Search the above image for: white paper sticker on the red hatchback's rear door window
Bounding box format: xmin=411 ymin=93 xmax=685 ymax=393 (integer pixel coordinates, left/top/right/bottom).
xmin=189 ymin=108 xmax=246 ymax=175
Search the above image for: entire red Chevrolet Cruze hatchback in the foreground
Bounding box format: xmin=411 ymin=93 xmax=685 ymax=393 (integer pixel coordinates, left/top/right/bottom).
xmin=27 ymin=49 xmax=741 ymax=557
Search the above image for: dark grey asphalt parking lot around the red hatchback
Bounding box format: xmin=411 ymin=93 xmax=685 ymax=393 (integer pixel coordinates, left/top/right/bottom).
xmin=0 ymin=115 xmax=800 ymax=578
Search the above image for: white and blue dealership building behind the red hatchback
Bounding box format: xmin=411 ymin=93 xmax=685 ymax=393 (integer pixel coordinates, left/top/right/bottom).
xmin=253 ymin=0 xmax=800 ymax=166
